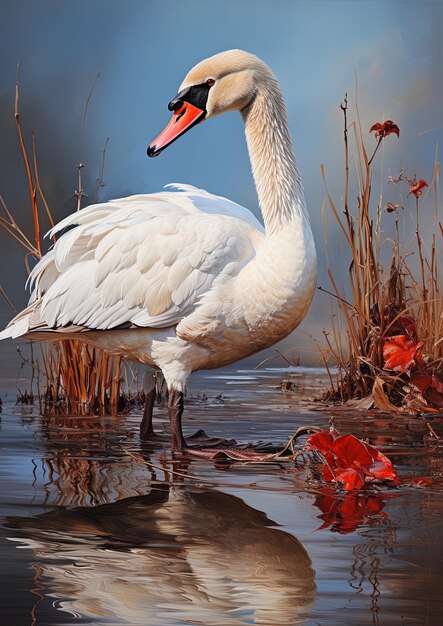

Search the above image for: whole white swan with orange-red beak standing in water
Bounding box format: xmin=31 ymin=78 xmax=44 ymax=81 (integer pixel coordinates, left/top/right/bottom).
xmin=0 ymin=50 xmax=316 ymax=457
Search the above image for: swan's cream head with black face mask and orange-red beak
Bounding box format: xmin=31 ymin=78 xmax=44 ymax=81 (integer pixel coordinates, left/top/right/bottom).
xmin=148 ymin=50 xmax=275 ymax=157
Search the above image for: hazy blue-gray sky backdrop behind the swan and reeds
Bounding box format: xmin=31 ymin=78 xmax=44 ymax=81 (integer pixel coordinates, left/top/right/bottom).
xmin=0 ymin=0 xmax=443 ymax=363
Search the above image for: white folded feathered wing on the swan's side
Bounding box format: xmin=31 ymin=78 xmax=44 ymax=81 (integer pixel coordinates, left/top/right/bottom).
xmin=16 ymin=187 xmax=263 ymax=330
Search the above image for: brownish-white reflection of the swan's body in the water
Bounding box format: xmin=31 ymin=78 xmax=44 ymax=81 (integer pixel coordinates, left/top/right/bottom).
xmin=7 ymin=485 xmax=316 ymax=626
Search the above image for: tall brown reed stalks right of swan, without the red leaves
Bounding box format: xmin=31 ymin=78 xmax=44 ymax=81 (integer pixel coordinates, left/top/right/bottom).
xmin=321 ymin=97 xmax=443 ymax=407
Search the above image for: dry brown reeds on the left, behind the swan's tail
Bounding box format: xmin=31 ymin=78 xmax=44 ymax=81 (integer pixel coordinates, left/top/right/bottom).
xmin=0 ymin=69 xmax=143 ymax=415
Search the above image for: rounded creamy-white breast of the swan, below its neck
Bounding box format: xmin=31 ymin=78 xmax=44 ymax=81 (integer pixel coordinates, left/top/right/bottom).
xmin=177 ymin=221 xmax=317 ymax=368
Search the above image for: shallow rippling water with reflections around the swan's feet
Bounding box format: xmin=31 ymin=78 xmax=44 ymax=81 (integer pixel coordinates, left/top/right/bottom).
xmin=0 ymin=368 xmax=443 ymax=626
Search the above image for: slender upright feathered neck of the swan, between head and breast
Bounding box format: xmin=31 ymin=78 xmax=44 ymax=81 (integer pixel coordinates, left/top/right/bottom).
xmin=242 ymin=74 xmax=309 ymax=235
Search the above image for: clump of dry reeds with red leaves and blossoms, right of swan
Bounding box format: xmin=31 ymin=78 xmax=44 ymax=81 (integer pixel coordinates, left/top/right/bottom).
xmin=320 ymin=98 xmax=443 ymax=413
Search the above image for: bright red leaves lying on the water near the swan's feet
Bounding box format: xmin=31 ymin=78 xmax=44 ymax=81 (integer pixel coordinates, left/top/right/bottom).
xmin=308 ymin=430 xmax=397 ymax=491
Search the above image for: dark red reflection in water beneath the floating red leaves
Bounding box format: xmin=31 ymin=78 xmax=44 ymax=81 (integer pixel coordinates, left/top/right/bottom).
xmin=314 ymin=488 xmax=387 ymax=534
